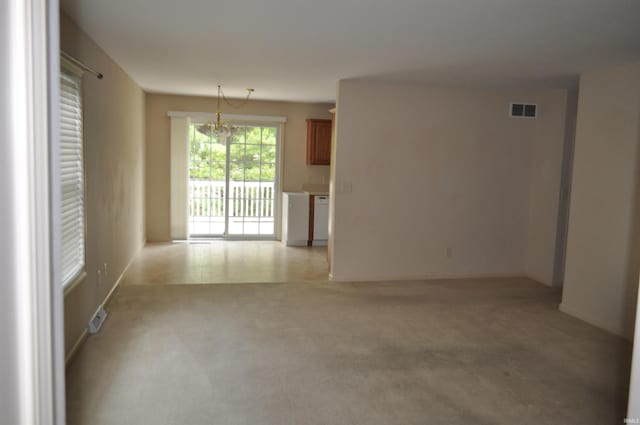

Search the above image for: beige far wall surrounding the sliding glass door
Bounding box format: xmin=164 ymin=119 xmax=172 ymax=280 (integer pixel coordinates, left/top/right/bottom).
xmin=146 ymin=93 xmax=333 ymax=242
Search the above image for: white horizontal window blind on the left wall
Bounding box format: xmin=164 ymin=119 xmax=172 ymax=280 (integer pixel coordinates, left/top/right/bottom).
xmin=60 ymin=70 xmax=85 ymax=286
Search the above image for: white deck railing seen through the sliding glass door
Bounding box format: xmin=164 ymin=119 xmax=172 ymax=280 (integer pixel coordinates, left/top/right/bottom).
xmin=188 ymin=180 xmax=276 ymax=217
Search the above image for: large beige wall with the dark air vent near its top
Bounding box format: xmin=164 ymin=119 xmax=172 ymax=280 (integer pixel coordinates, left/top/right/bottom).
xmin=330 ymin=80 xmax=566 ymax=284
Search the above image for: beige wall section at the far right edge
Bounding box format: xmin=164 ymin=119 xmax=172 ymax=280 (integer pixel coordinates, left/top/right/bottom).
xmin=561 ymin=62 xmax=640 ymax=338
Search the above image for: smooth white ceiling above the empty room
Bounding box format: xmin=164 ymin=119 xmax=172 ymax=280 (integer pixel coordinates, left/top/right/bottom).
xmin=61 ymin=0 xmax=640 ymax=101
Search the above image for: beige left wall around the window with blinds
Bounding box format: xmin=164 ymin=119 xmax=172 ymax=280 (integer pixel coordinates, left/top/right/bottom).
xmin=60 ymin=15 xmax=145 ymax=353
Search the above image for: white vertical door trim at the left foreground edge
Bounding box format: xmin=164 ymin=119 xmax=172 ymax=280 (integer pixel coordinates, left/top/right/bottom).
xmin=3 ymin=0 xmax=65 ymax=425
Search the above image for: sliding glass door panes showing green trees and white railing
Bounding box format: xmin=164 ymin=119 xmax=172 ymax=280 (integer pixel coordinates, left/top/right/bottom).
xmin=187 ymin=123 xmax=280 ymax=239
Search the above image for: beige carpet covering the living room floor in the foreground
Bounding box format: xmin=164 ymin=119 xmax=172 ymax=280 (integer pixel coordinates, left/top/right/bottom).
xmin=67 ymin=279 xmax=630 ymax=425
